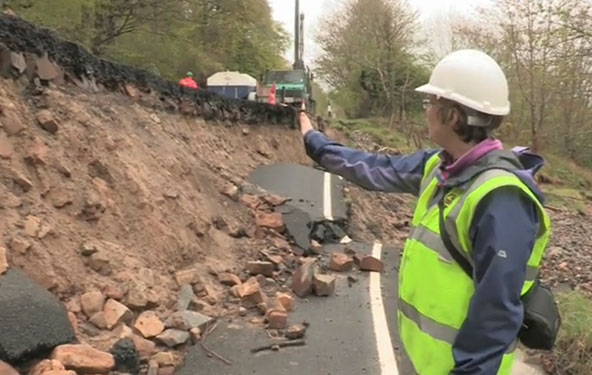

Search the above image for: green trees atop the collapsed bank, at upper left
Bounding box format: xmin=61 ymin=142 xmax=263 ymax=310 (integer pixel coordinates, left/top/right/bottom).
xmin=4 ymin=0 xmax=289 ymax=85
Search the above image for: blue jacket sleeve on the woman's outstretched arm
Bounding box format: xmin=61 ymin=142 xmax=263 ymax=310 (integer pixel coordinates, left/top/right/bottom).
xmin=304 ymin=130 xmax=438 ymax=195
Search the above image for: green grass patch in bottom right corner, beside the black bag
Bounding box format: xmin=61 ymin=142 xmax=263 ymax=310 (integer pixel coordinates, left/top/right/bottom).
xmin=553 ymin=291 xmax=592 ymax=375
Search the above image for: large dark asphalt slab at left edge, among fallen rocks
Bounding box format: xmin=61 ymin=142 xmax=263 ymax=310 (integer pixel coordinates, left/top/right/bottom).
xmin=0 ymin=268 xmax=75 ymax=364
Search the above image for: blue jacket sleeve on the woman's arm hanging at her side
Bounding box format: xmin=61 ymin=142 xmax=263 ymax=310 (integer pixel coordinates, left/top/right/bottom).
xmin=451 ymin=187 xmax=539 ymax=375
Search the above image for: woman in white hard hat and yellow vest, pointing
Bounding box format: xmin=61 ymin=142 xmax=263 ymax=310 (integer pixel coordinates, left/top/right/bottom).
xmin=300 ymin=50 xmax=556 ymax=375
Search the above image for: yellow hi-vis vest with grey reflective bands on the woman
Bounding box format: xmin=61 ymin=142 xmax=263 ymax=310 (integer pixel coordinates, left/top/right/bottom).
xmin=398 ymin=151 xmax=550 ymax=375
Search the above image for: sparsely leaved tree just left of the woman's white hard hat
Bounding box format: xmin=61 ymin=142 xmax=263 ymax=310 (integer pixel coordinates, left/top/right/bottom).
xmin=316 ymin=0 xmax=425 ymax=124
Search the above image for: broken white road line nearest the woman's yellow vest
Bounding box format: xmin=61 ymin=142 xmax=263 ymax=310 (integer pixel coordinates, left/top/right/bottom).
xmin=370 ymin=242 xmax=399 ymax=375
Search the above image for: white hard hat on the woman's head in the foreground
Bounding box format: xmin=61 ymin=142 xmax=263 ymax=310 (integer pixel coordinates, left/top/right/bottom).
xmin=415 ymin=49 xmax=510 ymax=116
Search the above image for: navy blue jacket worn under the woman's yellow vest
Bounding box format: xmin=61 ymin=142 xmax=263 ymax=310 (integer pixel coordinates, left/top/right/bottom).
xmin=304 ymin=131 xmax=544 ymax=375
